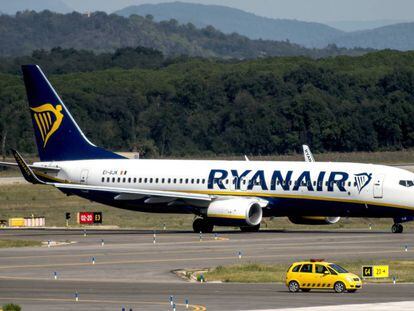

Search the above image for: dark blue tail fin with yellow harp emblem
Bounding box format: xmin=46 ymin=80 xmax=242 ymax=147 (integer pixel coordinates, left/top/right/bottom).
xmin=22 ymin=65 xmax=123 ymax=161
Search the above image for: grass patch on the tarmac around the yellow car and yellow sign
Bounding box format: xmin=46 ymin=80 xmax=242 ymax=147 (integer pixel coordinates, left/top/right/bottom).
xmin=203 ymin=260 xmax=414 ymax=283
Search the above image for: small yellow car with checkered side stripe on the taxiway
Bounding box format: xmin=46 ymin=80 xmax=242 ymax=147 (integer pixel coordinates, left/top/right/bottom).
xmin=286 ymin=259 xmax=362 ymax=293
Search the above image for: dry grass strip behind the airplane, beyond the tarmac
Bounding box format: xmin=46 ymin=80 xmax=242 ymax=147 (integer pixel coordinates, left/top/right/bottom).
xmin=0 ymin=184 xmax=414 ymax=230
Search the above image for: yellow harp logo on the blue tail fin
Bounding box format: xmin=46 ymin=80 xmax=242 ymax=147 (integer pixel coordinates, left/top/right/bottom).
xmin=30 ymin=104 xmax=63 ymax=148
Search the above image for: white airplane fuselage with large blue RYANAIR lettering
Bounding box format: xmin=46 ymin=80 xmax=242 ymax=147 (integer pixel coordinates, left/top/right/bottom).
xmin=37 ymin=159 xmax=414 ymax=217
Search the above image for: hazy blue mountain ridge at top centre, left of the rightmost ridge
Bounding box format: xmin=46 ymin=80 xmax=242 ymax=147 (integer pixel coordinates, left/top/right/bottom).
xmin=115 ymin=2 xmax=344 ymax=47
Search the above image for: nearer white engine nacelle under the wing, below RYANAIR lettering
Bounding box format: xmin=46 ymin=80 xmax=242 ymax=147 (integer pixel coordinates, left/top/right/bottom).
xmin=207 ymin=198 xmax=263 ymax=226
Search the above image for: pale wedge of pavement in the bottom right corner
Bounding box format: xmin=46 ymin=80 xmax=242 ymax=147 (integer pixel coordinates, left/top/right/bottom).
xmin=250 ymin=301 xmax=414 ymax=311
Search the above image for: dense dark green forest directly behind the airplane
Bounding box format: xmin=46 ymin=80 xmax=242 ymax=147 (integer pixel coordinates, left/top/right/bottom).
xmin=0 ymin=51 xmax=414 ymax=157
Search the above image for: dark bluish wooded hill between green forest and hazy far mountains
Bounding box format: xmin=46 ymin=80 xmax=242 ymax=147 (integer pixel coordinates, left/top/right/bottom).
xmin=0 ymin=11 xmax=366 ymax=59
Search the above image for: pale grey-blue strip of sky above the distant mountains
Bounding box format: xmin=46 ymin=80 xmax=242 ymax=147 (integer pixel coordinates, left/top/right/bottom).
xmin=63 ymin=0 xmax=414 ymax=22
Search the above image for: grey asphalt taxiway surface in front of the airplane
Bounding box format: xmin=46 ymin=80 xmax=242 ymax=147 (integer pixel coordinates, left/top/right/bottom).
xmin=0 ymin=230 xmax=414 ymax=311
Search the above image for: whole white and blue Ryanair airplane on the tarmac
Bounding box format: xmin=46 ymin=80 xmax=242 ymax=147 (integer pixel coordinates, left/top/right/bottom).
xmin=0 ymin=65 xmax=414 ymax=233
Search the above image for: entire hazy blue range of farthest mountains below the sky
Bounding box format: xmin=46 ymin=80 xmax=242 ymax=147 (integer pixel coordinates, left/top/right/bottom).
xmin=115 ymin=2 xmax=414 ymax=50
